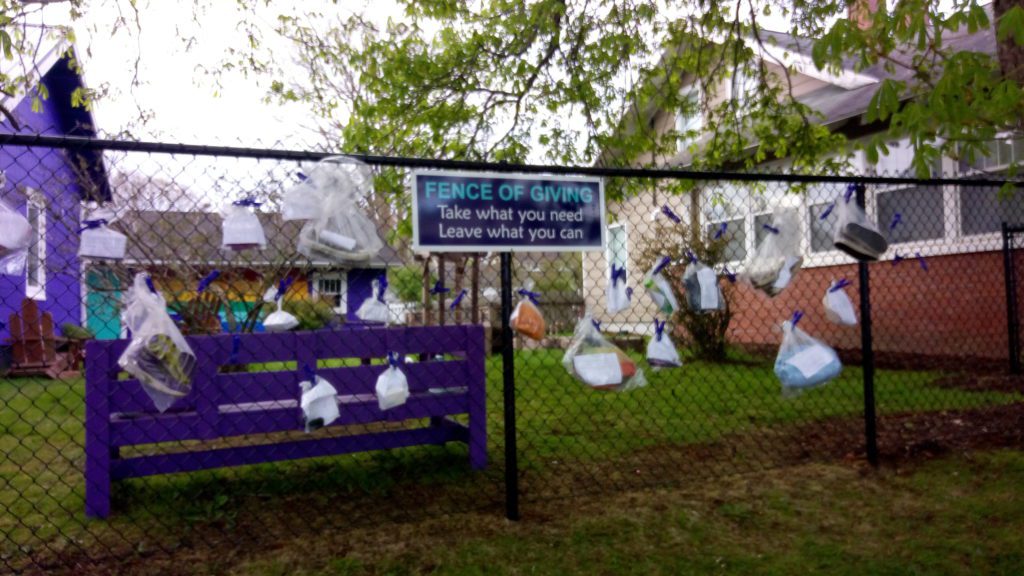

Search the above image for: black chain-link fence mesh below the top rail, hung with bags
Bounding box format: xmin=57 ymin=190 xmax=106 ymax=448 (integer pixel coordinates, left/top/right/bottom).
xmin=0 ymin=132 xmax=1024 ymax=573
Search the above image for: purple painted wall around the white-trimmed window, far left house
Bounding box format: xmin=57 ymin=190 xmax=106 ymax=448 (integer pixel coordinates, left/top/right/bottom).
xmin=0 ymin=59 xmax=105 ymax=341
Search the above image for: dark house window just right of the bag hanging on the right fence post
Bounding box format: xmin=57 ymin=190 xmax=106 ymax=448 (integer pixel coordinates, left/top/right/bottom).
xmin=876 ymin=187 xmax=945 ymax=244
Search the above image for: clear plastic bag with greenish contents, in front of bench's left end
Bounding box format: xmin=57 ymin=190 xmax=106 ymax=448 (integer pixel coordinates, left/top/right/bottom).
xmin=118 ymin=273 xmax=196 ymax=412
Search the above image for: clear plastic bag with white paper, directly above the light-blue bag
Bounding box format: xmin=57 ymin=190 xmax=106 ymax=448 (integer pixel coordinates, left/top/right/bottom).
xmin=743 ymin=209 xmax=804 ymax=296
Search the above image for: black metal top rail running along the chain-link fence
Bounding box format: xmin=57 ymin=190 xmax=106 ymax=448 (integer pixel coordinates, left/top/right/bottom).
xmin=0 ymin=133 xmax=1024 ymax=188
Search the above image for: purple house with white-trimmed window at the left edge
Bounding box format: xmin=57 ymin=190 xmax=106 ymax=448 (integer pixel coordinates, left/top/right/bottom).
xmin=0 ymin=45 xmax=110 ymax=341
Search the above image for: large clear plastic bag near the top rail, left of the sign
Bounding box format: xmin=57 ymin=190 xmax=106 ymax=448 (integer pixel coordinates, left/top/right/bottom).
xmin=298 ymin=158 xmax=384 ymax=262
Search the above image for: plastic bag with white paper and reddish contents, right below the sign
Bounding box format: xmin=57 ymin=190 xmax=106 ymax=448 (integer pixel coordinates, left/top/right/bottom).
xmin=562 ymin=315 xmax=647 ymax=392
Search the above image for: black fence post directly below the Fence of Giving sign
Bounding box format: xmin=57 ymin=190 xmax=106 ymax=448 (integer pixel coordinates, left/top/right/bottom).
xmin=502 ymin=252 xmax=519 ymax=520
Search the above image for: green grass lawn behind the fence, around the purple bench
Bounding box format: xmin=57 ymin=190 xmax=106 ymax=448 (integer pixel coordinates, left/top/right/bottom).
xmin=0 ymin=344 xmax=1024 ymax=566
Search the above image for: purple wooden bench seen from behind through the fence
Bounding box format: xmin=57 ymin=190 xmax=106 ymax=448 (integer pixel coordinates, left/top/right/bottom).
xmin=85 ymin=326 xmax=487 ymax=518
